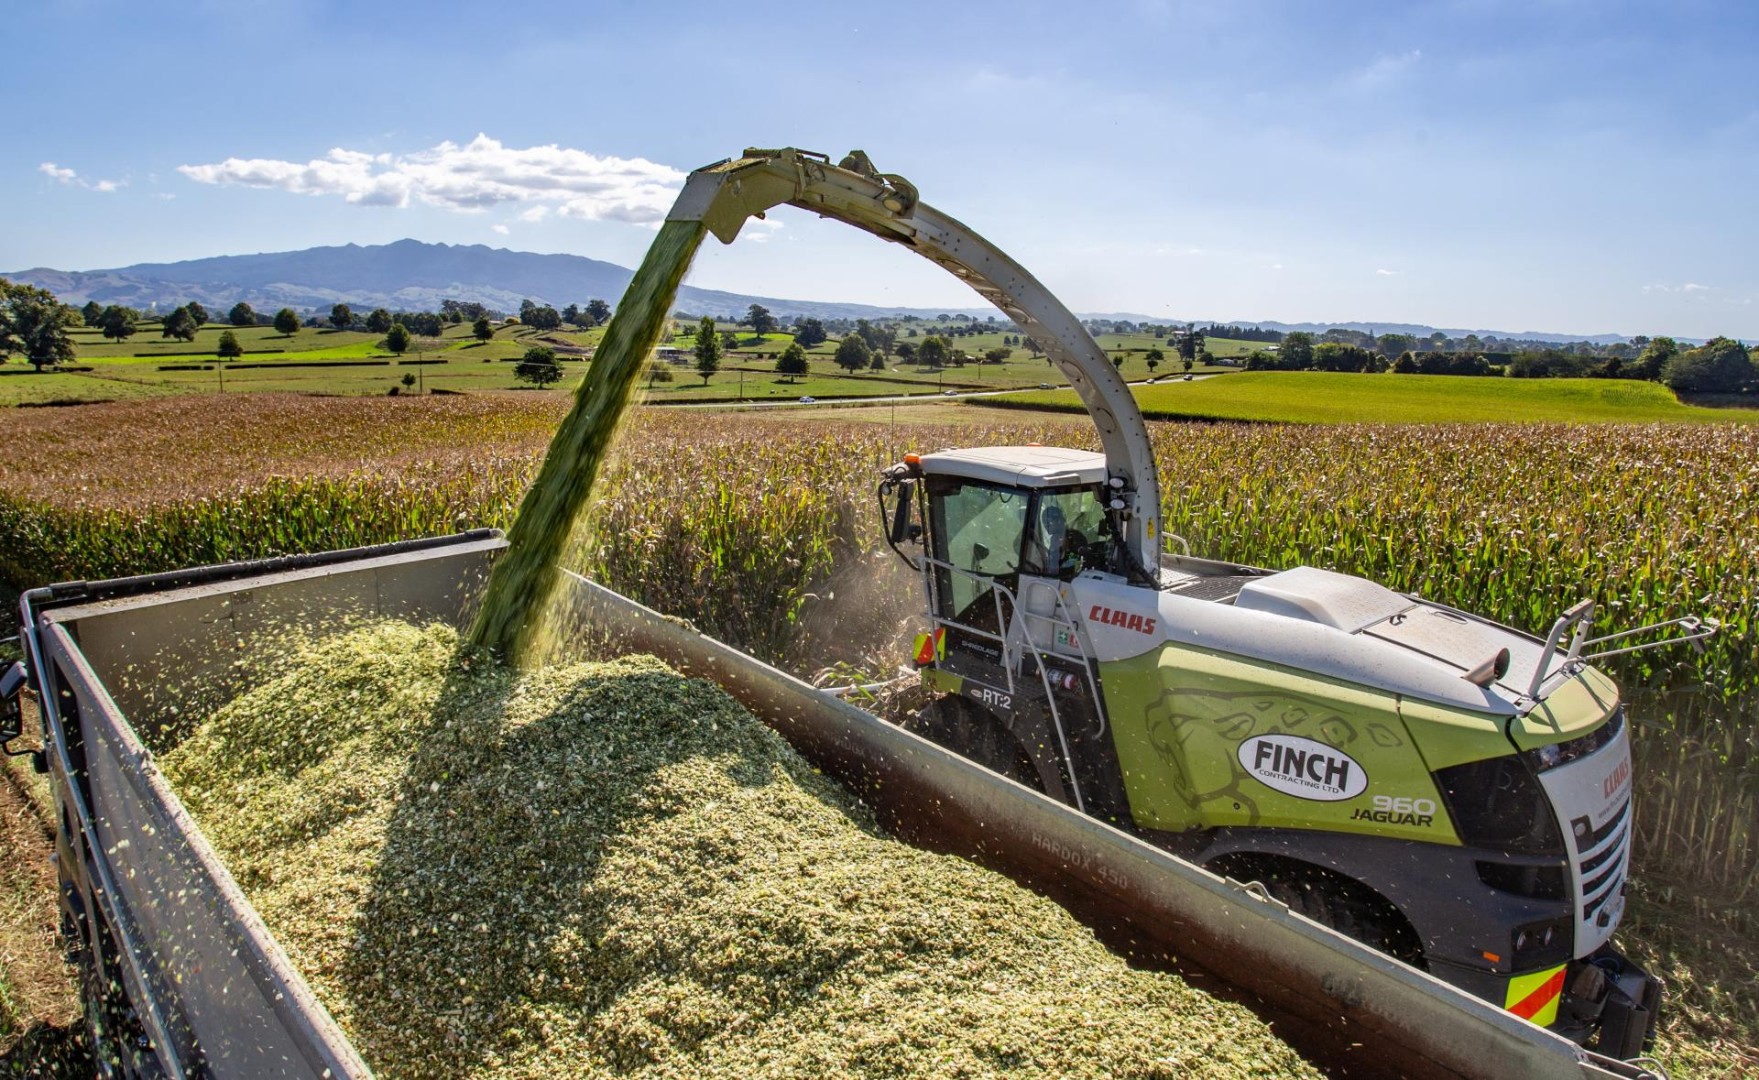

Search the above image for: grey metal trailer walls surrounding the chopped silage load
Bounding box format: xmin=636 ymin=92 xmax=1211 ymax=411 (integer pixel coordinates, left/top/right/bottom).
xmin=0 ymin=531 xmax=1653 ymax=1080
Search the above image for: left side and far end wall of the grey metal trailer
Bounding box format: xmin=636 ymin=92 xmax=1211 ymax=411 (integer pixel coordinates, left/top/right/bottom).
xmin=33 ymin=538 xmax=505 ymax=1080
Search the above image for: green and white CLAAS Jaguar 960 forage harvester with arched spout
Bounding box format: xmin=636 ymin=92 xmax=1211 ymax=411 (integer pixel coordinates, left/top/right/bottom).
xmin=668 ymin=150 xmax=1715 ymax=1057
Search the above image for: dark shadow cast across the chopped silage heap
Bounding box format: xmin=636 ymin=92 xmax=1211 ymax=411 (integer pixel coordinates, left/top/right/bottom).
xmin=338 ymin=650 xmax=872 ymax=1076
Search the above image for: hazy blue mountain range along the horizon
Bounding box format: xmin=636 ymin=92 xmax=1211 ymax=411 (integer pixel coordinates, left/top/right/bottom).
xmin=0 ymin=239 xmax=1627 ymax=345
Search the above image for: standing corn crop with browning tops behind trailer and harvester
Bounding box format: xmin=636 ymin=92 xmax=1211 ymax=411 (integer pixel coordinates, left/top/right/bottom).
xmin=0 ymin=396 xmax=1759 ymax=897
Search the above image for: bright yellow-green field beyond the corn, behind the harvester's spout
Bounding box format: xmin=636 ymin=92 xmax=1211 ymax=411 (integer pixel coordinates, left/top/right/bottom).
xmin=985 ymin=371 xmax=1759 ymax=424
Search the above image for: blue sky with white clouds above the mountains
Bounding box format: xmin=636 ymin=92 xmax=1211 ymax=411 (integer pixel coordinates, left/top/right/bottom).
xmin=0 ymin=0 xmax=1759 ymax=339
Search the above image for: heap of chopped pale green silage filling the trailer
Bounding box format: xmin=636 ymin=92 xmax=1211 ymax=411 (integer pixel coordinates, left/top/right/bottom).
xmin=162 ymin=624 xmax=1316 ymax=1078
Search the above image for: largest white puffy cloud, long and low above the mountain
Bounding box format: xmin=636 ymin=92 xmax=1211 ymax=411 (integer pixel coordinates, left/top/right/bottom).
xmin=178 ymin=134 xmax=684 ymax=225
